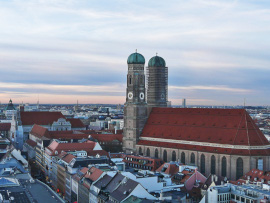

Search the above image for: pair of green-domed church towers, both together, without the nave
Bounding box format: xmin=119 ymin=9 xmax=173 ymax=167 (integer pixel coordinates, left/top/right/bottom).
xmin=123 ymin=52 xmax=168 ymax=153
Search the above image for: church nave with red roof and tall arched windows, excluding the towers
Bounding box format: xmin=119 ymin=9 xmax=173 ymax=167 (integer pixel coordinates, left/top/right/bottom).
xmin=137 ymin=108 xmax=270 ymax=180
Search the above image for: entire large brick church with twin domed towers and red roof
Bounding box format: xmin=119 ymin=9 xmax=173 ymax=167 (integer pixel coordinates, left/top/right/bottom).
xmin=123 ymin=52 xmax=270 ymax=180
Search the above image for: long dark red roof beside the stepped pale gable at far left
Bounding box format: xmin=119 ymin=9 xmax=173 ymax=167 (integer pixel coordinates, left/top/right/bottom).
xmin=20 ymin=111 xmax=65 ymax=125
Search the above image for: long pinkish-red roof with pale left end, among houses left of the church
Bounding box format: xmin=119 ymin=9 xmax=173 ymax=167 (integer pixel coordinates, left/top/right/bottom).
xmin=47 ymin=141 xmax=96 ymax=156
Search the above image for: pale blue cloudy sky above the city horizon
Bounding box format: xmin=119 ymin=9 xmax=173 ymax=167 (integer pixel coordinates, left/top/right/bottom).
xmin=0 ymin=0 xmax=270 ymax=105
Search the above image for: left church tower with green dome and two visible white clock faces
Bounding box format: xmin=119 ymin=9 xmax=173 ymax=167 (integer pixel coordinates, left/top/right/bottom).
xmin=123 ymin=52 xmax=147 ymax=153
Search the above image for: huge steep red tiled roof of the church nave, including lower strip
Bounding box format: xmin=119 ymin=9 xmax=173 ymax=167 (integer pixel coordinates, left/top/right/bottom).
xmin=138 ymin=108 xmax=269 ymax=155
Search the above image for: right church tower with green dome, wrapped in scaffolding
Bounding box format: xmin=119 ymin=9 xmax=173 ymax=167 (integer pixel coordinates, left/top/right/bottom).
xmin=146 ymin=56 xmax=168 ymax=113
